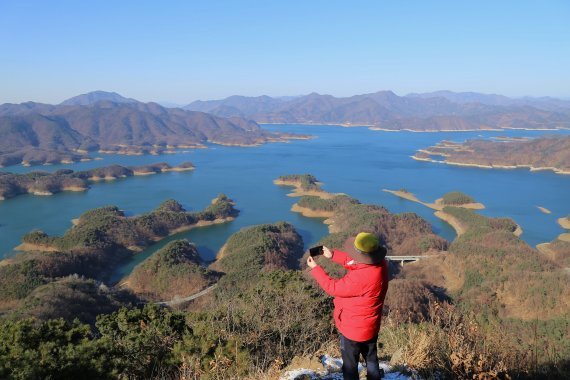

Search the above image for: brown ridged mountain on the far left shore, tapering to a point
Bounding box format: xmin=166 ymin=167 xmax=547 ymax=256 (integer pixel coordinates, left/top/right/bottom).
xmin=0 ymin=95 xmax=307 ymax=166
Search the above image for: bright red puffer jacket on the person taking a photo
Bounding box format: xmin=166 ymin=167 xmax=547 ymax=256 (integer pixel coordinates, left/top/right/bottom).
xmin=311 ymin=249 xmax=388 ymax=342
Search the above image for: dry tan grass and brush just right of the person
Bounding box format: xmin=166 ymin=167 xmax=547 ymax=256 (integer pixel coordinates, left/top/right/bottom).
xmin=381 ymin=303 xmax=532 ymax=379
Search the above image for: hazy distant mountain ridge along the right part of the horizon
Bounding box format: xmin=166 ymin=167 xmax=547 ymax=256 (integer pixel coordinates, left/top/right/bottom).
xmin=184 ymin=91 xmax=570 ymax=131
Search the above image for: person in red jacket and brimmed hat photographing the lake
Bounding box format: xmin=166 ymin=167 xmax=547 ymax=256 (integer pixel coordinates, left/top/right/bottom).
xmin=307 ymin=232 xmax=389 ymax=380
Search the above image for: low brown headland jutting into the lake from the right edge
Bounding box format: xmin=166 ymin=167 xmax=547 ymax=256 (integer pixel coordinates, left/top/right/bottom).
xmin=412 ymin=136 xmax=570 ymax=174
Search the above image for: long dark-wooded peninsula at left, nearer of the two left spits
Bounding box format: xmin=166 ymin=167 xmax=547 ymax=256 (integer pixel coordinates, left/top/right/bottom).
xmin=0 ymin=194 xmax=238 ymax=311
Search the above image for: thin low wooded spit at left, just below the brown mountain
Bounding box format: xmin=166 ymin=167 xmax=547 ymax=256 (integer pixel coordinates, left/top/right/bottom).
xmin=0 ymin=162 xmax=194 ymax=201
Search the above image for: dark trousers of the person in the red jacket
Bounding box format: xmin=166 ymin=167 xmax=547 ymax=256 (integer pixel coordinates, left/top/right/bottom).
xmin=340 ymin=334 xmax=384 ymax=380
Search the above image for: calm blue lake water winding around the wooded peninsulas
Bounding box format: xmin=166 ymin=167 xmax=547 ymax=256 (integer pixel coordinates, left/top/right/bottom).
xmin=0 ymin=125 xmax=570 ymax=278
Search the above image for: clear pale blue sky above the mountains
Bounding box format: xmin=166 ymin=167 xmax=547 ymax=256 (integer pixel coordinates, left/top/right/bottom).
xmin=0 ymin=0 xmax=570 ymax=104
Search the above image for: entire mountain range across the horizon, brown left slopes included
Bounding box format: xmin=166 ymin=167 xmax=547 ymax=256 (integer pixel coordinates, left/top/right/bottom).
xmin=0 ymin=91 xmax=570 ymax=166
